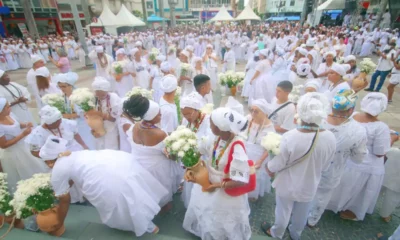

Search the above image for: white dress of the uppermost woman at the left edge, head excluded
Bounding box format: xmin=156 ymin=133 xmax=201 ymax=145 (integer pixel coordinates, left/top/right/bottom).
xmin=0 ymin=82 xmax=36 ymax=125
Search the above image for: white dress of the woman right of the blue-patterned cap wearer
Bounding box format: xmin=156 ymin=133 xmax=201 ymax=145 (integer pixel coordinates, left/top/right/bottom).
xmin=327 ymin=121 xmax=390 ymax=220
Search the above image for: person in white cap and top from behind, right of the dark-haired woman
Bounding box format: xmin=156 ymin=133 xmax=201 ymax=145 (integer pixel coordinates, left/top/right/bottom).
xmin=160 ymin=75 xmax=180 ymax=133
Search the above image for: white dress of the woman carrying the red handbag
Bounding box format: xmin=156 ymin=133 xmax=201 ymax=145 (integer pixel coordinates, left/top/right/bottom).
xmin=183 ymin=137 xmax=251 ymax=240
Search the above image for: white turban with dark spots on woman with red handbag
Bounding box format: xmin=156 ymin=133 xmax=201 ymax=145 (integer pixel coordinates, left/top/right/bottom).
xmin=211 ymin=107 xmax=247 ymax=134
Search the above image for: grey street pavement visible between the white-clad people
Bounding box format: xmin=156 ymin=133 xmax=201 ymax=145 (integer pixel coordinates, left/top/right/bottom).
xmin=0 ymin=57 xmax=400 ymax=240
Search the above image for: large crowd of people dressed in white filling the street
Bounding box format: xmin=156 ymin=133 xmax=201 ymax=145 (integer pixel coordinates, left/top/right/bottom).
xmin=0 ymin=20 xmax=400 ymax=240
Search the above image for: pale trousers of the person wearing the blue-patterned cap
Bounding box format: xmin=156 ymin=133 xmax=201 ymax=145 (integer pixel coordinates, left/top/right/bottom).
xmin=308 ymin=188 xmax=334 ymax=226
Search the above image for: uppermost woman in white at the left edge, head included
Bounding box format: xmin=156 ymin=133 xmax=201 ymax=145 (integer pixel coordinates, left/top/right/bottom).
xmin=0 ymin=70 xmax=36 ymax=125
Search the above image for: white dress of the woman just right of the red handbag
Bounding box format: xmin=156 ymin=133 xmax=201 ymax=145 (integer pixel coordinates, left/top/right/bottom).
xmin=246 ymin=115 xmax=275 ymax=199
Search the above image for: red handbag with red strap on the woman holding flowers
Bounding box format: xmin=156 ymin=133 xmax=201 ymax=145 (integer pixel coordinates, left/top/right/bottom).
xmin=223 ymin=141 xmax=256 ymax=197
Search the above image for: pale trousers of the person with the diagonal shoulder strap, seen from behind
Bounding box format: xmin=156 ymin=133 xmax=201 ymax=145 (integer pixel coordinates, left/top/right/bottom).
xmin=271 ymin=196 xmax=311 ymax=240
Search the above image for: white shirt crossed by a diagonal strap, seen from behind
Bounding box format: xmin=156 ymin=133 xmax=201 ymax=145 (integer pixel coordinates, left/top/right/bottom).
xmin=267 ymin=129 xmax=336 ymax=202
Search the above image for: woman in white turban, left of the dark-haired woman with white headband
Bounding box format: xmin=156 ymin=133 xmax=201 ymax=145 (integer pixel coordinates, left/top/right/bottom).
xmin=92 ymin=77 xmax=121 ymax=150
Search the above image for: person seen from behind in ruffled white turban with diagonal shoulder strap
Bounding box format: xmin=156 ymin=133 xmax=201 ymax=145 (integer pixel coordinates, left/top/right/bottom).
xmin=261 ymin=93 xmax=336 ymax=240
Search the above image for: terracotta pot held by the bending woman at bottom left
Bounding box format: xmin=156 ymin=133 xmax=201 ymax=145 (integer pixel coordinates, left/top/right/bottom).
xmin=36 ymin=207 xmax=65 ymax=237
